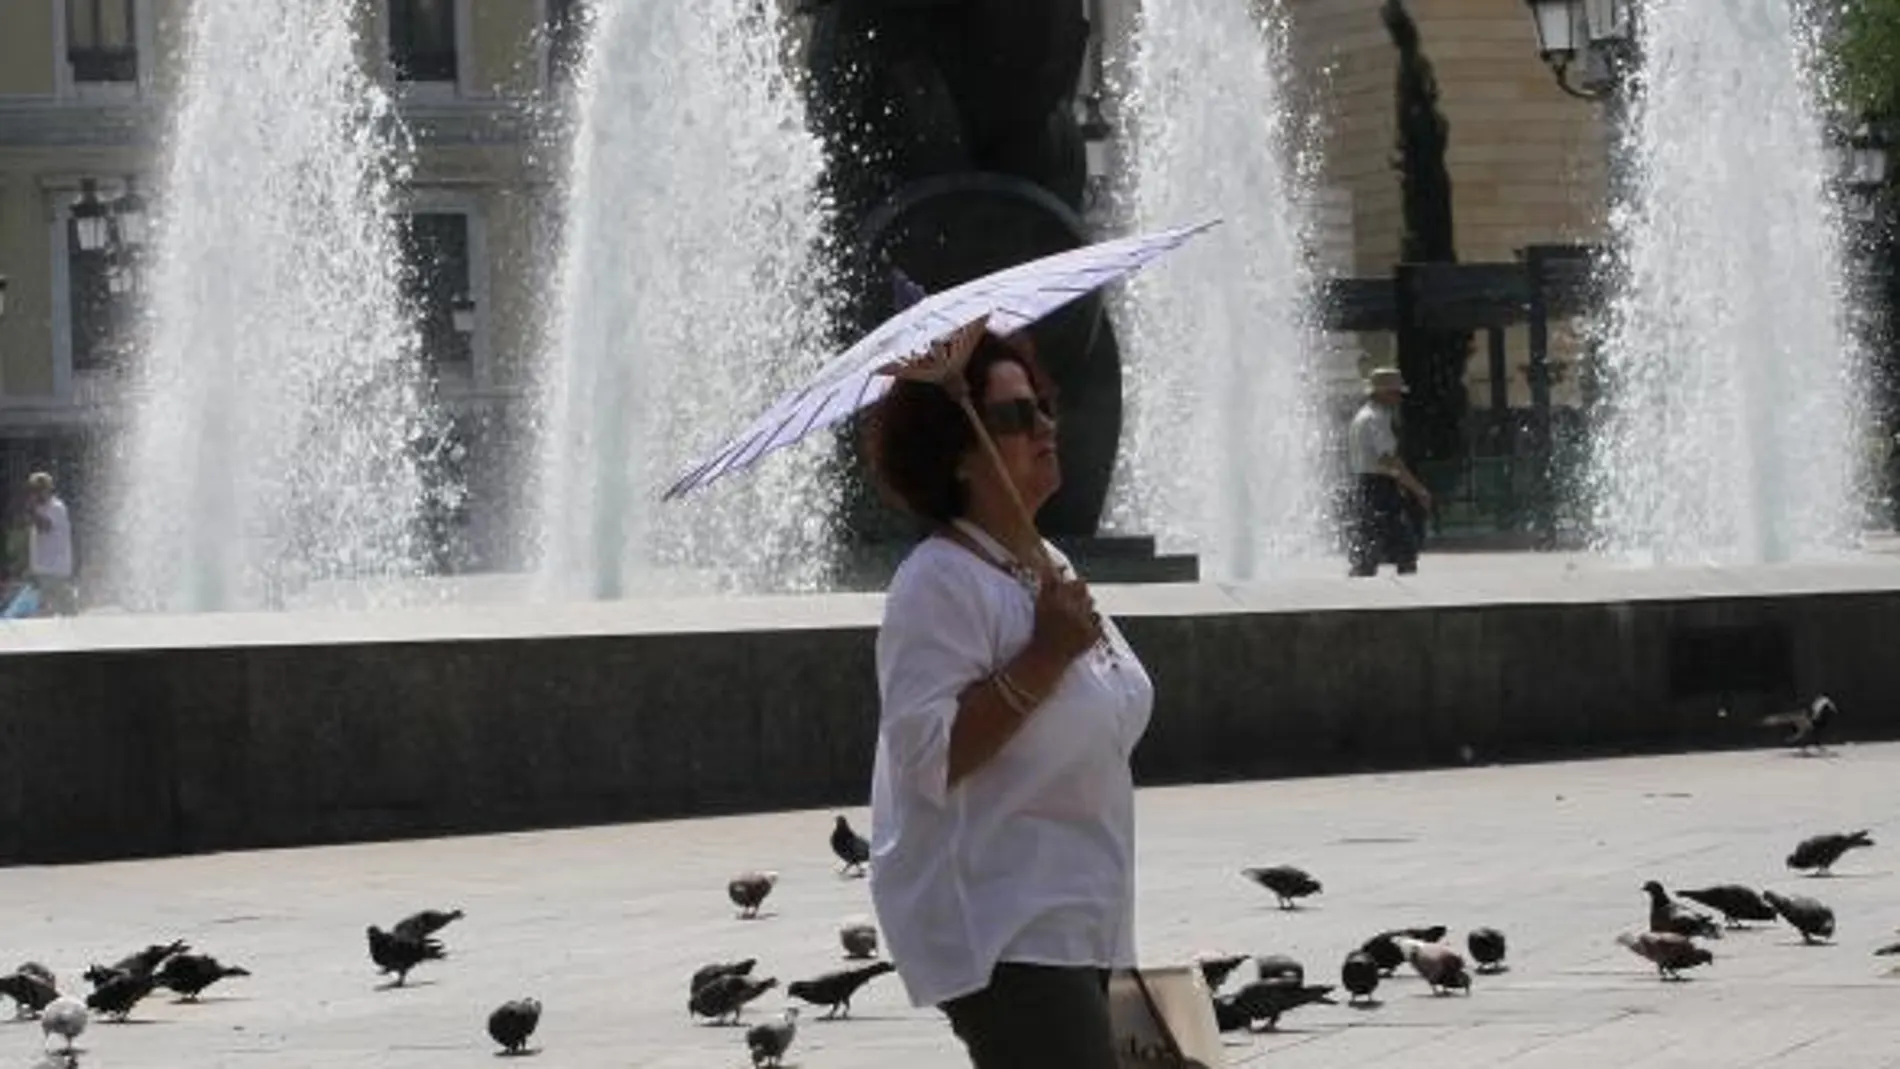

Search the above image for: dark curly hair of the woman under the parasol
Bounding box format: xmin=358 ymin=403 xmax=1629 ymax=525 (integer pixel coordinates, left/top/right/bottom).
xmin=863 ymin=334 xmax=1055 ymax=524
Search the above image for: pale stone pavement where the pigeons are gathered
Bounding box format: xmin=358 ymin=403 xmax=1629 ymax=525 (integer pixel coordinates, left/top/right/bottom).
xmin=0 ymin=746 xmax=1900 ymax=1069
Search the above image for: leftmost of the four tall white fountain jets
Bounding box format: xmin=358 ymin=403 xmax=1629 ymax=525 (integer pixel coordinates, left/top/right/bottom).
xmin=105 ymin=0 xmax=433 ymax=611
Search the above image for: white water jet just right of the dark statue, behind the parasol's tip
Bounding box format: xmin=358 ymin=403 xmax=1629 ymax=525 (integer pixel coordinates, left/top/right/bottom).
xmin=1113 ymin=0 xmax=1326 ymax=581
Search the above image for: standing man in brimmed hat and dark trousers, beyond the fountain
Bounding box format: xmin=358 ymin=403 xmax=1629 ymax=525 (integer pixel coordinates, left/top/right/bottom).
xmin=1345 ymin=368 xmax=1431 ymax=575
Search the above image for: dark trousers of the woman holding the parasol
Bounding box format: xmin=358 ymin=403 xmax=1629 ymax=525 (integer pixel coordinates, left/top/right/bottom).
xmin=942 ymin=961 xmax=1117 ymax=1069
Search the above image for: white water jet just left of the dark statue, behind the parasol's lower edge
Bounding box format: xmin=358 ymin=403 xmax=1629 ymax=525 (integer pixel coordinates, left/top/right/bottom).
xmin=534 ymin=0 xmax=832 ymax=598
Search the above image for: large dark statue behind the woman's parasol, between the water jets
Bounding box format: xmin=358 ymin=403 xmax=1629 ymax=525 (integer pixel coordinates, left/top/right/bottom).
xmin=804 ymin=0 xmax=1121 ymax=539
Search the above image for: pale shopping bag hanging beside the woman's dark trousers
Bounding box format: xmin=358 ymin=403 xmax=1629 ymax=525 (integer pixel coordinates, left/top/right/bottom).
xmin=1108 ymin=965 xmax=1227 ymax=1069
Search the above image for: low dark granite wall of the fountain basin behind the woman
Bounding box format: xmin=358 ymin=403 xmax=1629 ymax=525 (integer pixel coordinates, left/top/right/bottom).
xmin=0 ymin=591 xmax=1900 ymax=864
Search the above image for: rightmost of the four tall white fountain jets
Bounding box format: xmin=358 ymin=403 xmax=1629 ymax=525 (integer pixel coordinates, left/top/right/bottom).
xmin=1590 ymin=0 xmax=1866 ymax=564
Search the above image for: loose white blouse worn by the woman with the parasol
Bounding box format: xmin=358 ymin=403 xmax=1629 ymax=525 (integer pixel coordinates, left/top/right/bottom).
xmin=870 ymin=537 xmax=1153 ymax=1006
